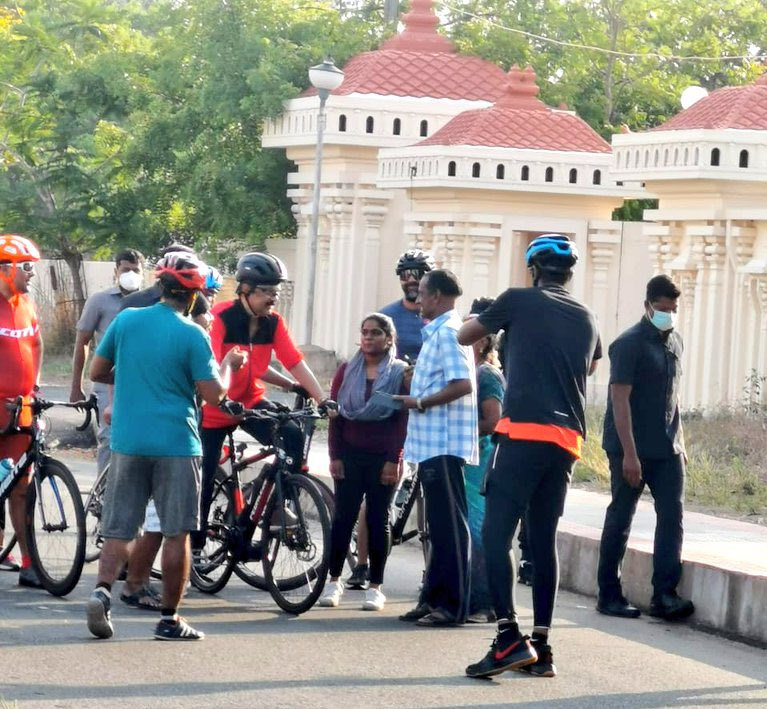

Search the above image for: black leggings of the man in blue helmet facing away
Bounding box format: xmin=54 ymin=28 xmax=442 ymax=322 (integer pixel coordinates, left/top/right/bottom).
xmin=482 ymin=439 xmax=575 ymax=627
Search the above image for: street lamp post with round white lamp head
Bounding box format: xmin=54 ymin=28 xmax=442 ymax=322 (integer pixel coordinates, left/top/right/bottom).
xmin=305 ymin=59 xmax=344 ymax=344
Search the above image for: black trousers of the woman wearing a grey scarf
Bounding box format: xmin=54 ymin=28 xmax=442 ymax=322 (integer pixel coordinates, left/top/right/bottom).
xmin=329 ymin=451 xmax=395 ymax=584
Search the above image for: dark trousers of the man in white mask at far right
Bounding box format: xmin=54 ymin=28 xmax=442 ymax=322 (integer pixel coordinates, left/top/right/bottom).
xmin=597 ymin=454 xmax=684 ymax=600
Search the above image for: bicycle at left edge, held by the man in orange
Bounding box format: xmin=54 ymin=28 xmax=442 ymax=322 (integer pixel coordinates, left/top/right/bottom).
xmin=0 ymin=396 xmax=98 ymax=596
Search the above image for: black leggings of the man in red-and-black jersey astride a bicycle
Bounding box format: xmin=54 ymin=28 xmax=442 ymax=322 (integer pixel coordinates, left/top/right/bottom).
xmin=192 ymin=401 xmax=304 ymax=549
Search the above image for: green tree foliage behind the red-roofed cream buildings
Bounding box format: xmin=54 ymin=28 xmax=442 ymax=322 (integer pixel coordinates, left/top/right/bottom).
xmin=0 ymin=0 xmax=767 ymax=294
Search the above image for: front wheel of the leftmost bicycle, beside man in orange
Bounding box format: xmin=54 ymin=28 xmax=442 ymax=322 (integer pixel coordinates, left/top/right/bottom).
xmin=27 ymin=457 xmax=85 ymax=596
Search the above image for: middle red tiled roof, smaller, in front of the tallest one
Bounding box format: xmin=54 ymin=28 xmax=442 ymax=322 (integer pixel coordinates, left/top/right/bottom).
xmin=418 ymin=66 xmax=611 ymax=153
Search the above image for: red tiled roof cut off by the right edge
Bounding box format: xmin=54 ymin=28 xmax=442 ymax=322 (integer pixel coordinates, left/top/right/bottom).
xmin=652 ymin=74 xmax=767 ymax=131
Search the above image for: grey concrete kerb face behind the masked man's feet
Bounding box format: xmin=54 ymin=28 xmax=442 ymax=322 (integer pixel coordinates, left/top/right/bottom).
xmin=559 ymin=520 xmax=767 ymax=645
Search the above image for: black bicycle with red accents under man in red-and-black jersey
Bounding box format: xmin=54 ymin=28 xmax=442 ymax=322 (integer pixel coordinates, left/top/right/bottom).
xmin=190 ymin=402 xmax=330 ymax=615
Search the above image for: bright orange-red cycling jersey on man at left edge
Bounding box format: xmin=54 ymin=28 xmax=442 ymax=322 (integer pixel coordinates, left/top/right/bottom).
xmin=0 ymin=295 xmax=40 ymax=428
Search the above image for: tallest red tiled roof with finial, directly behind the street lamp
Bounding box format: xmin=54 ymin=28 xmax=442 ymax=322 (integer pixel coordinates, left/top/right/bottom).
xmin=305 ymin=0 xmax=506 ymax=101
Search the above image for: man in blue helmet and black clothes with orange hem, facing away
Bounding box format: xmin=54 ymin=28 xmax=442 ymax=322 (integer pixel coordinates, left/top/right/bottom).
xmin=458 ymin=234 xmax=602 ymax=677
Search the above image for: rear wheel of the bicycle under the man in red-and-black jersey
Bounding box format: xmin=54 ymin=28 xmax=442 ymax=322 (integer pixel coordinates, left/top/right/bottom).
xmin=189 ymin=477 xmax=235 ymax=593
